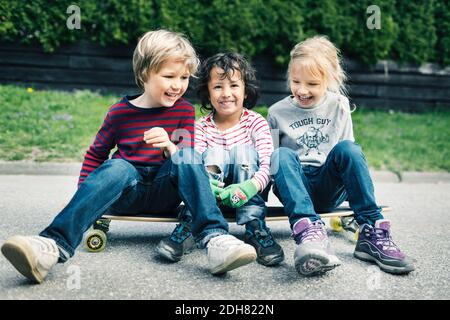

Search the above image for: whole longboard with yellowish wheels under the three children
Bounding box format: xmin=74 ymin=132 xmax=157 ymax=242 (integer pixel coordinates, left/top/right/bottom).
xmin=83 ymin=206 xmax=392 ymax=252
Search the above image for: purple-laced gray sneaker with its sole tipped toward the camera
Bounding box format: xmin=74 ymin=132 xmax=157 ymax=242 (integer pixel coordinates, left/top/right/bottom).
xmin=293 ymin=218 xmax=341 ymax=276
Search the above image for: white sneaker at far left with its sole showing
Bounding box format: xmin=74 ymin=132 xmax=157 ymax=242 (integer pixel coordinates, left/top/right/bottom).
xmin=2 ymin=236 xmax=59 ymax=283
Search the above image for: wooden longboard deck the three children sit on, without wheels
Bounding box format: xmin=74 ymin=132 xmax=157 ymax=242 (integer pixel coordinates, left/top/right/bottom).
xmin=102 ymin=206 xmax=392 ymax=222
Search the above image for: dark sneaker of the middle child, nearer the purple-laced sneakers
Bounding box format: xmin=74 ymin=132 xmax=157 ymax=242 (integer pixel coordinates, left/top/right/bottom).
xmin=244 ymin=220 xmax=284 ymax=266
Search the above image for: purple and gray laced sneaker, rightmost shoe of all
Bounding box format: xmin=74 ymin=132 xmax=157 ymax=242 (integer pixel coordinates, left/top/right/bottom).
xmin=353 ymin=219 xmax=414 ymax=274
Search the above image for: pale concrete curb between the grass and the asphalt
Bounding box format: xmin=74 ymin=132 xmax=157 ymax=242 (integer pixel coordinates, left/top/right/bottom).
xmin=0 ymin=161 xmax=450 ymax=183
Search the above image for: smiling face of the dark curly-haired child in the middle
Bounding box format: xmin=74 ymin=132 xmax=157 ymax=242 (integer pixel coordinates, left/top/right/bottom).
xmin=208 ymin=67 xmax=245 ymax=118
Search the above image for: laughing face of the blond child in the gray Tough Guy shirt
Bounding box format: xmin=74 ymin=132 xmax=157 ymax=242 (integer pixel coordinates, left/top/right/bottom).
xmin=289 ymin=61 xmax=326 ymax=108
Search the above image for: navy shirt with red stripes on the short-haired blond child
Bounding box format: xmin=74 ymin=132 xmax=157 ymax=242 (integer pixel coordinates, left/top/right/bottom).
xmin=78 ymin=95 xmax=195 ymax=185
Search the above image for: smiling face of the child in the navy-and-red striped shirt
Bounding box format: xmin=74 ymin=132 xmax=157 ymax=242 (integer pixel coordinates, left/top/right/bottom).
xmin=144 ymin=58 xmax=190 ymax=107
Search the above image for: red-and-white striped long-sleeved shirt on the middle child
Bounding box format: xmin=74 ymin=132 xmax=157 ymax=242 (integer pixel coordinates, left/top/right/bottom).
xmin=195 ymin=108 xmax=273 ymax=190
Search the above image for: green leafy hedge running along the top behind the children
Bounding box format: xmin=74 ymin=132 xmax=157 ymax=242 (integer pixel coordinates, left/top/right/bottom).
xmin=0 ymin=0 xmax=450 ymax=65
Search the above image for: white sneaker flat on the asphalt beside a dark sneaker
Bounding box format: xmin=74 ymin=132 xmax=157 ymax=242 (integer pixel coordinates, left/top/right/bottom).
xmin=207 ymin=234 xmax=256 ymax=274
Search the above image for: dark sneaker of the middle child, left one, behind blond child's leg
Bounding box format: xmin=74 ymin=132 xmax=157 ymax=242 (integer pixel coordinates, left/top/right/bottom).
xmin=156 ymin=222 xmax=196 ymax=262
